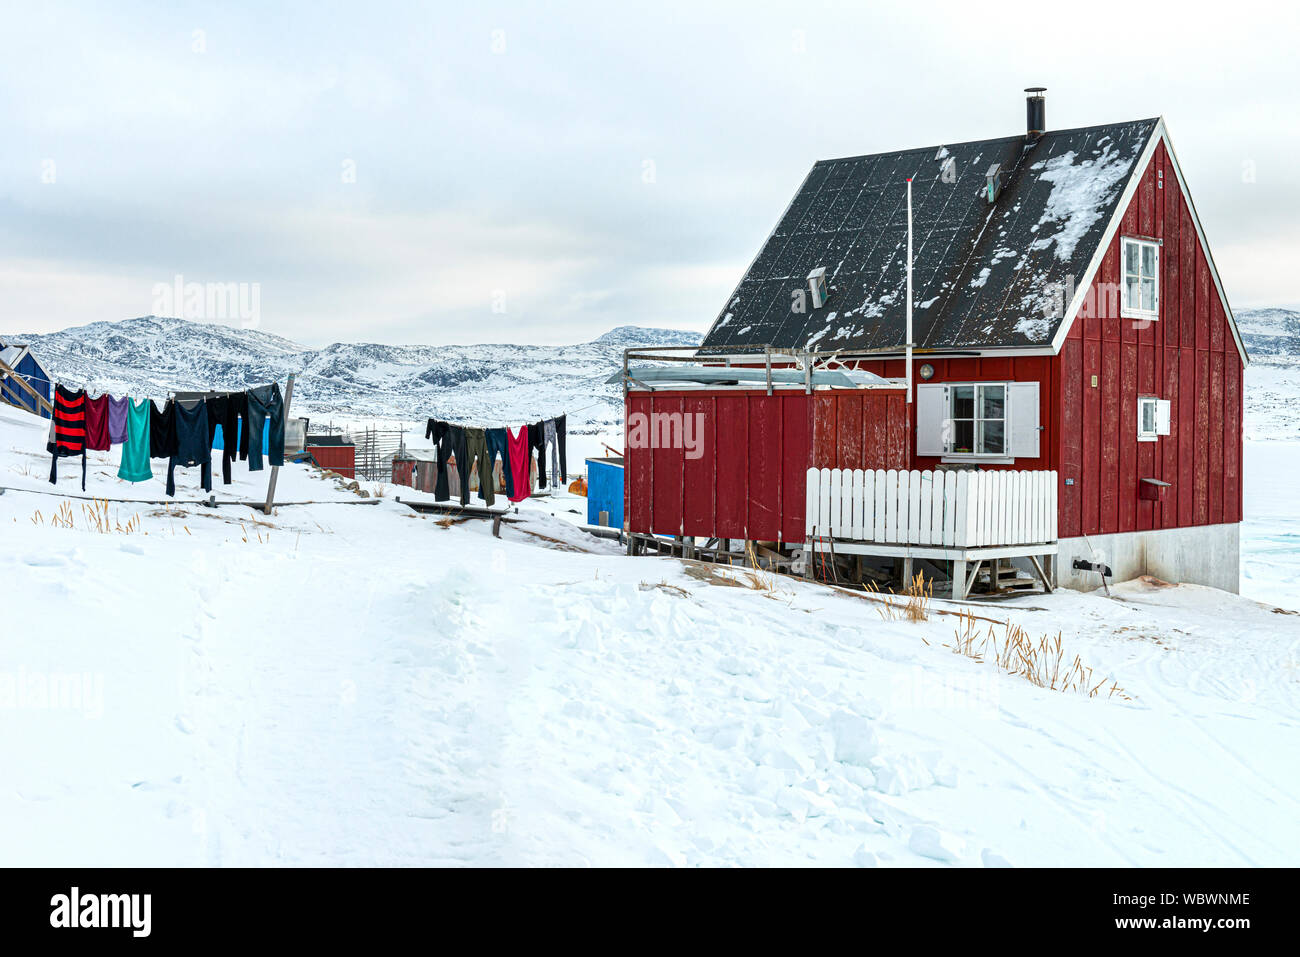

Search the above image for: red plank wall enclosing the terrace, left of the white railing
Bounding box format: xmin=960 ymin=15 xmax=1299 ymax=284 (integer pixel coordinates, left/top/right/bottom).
xmin=624 ymin=390 xmax=911 ymax=542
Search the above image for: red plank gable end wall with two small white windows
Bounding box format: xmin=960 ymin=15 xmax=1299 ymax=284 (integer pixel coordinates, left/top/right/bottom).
xmin=1055 ymin=144 xmax=1243 ymax=537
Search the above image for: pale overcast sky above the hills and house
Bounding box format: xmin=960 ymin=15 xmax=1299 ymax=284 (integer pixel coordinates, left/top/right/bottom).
xmin=0 ymin=0 xmax=1300 ymax=345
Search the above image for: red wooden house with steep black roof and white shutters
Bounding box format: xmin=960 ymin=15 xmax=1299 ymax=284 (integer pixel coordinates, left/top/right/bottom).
xmin=627 ymin=90 xmax=1247 ymax=592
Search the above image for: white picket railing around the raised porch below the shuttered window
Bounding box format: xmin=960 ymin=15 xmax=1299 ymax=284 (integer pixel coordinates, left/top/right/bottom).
xmin=805 ymin=468 xmax=1057 ymax=547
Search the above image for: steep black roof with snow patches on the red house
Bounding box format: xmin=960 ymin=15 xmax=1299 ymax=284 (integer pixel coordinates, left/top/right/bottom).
xmin=703 ymin=120 xmax=1158 ymax=351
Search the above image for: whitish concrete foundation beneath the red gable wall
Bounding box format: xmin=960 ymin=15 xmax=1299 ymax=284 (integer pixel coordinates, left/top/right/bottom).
xmin=1053 ymin=523 xmax=1242 ymax=594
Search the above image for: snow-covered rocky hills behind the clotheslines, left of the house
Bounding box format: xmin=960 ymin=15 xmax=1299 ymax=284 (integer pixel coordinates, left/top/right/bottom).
xmin=12 ymin=316 xmax=701 ymax=430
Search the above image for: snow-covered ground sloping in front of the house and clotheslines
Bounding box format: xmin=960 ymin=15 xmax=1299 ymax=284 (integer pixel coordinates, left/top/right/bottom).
xmin=0 ymin=408 xmax=1300 ymax=866
